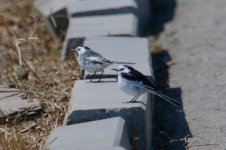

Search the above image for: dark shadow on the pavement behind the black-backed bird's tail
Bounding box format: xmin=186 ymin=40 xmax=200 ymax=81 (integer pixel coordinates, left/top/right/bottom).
xmin=152 ymin=50 xmax=191 ymax=150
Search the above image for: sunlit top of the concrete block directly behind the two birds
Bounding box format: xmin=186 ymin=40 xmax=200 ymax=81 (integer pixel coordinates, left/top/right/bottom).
xmin=83 ymin=37 xmax=152 ymax=78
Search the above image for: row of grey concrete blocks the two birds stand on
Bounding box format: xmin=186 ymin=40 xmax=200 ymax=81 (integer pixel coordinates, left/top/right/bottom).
xmin=34 ymin=0 xmax=153 ymax=150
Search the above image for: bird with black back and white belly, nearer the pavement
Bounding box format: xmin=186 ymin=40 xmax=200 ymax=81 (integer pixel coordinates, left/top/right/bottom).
xmin=112 ymin=65 xmax=181 ymax=107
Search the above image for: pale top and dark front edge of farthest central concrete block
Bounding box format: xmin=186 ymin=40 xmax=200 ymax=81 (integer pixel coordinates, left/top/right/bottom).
xmin=67 ymin=0 xmax=138 ymax=17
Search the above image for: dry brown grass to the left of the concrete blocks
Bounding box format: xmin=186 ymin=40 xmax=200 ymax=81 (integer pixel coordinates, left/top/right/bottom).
xmin=0 ymin=0 xmax=78 ymax=150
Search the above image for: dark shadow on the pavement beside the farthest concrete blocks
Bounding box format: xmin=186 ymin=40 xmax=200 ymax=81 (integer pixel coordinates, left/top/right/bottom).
xmin=149 ymin=0 xmax=177 ymax=35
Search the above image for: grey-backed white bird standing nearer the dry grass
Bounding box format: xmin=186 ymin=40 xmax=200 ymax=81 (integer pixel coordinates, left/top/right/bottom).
xmin=72 ymin=46 xmax=133 ymax=82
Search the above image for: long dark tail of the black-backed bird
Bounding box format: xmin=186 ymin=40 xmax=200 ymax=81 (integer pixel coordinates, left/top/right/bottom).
xmin=150 ymin=90 xmax=181 ymax=108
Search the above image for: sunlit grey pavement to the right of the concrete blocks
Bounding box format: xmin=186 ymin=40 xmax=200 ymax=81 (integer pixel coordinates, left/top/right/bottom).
xmin=154 ymin=0 xmax=226 ymax=150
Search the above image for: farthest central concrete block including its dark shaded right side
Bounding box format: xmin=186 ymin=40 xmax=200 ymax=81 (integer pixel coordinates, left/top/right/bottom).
xmin=67 ymin=0 xmax=151 ymax=36
